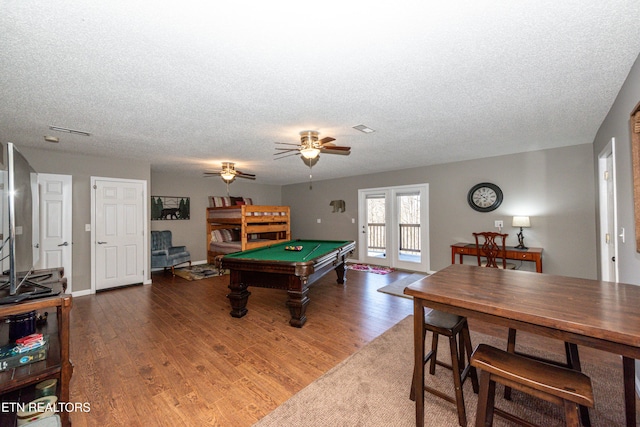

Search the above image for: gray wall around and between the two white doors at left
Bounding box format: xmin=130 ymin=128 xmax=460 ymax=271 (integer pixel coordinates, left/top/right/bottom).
xmin=16 ymin=148 xmax=150 ymax=292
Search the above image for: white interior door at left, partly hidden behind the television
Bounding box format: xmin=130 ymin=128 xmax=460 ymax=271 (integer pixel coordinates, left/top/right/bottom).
xmin=36 ymin=173 xmax=73 ymax=293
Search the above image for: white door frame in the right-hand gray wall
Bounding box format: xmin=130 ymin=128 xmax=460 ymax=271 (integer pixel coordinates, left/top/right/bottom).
xmin=598 ymin=138 xmax=624 ymax=282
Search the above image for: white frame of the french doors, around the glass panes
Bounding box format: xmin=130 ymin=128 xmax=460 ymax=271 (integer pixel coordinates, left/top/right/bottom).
xmin=358 ymin=183 xmax=430 ymax=272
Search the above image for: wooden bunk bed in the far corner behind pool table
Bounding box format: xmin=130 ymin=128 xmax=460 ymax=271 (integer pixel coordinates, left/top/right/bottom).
xmin=207 ymin=204 xmax=291 ymax=264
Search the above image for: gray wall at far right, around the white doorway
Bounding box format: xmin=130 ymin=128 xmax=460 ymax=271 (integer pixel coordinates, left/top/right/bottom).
xmin=593 ymin=54 xmax=640 ymax=285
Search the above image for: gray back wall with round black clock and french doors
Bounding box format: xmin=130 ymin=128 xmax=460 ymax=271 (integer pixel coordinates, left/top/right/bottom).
xmin=282 ymin=143 xmax=597 ymax=278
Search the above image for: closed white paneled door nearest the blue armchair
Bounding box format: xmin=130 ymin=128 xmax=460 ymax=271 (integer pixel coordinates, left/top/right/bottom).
xmin=92 ymin=178 xmax=147 ymax=290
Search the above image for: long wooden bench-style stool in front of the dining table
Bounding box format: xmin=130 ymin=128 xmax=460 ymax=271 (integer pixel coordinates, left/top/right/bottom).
xmin=471 ymin=344 xmax=593 ymax=427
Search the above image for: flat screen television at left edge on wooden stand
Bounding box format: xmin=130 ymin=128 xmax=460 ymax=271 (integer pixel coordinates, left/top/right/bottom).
xmin=0 ymin=142 xmax=46 ymax=296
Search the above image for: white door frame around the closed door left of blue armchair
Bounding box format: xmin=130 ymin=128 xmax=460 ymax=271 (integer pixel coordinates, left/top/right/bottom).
xmin=91 ymin=176 xmax=151 ymax=294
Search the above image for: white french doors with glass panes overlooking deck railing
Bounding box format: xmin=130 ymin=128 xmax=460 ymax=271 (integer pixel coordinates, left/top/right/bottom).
xmin=358 ymin=184 xmax=429 ymax=272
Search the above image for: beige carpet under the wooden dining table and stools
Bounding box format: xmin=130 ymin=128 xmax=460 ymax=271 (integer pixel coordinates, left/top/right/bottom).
xmin=254 ymin=316 xmax=636 ymax=427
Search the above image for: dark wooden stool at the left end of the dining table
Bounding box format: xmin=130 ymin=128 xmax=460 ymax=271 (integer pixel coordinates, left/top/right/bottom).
xmin=409 ymin=310 xmax=478 ymax=427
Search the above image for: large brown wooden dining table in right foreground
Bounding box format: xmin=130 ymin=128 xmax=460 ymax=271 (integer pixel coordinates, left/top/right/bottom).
xmin=404 ymin=264 xmax=640 ymax=427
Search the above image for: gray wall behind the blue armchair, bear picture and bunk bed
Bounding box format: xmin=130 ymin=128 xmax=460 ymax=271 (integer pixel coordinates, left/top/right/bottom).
xmin=150 ymin=172 xmax=282 ymax=262
